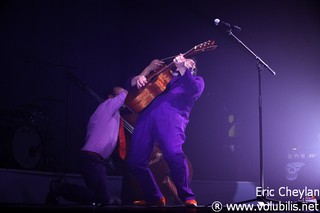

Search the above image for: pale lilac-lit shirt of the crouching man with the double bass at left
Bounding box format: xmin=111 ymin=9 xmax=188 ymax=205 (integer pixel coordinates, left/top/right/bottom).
xmin=81 ymin=91 xmax=127 ymax=159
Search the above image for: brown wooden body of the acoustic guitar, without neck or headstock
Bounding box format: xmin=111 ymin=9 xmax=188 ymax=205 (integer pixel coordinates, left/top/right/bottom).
xmin=124 ymin=68 xmax=173 ymax=113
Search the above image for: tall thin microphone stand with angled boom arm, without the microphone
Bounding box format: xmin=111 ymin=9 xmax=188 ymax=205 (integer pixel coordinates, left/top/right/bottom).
xmin=227 ymin=28 xmax=278 ymax=204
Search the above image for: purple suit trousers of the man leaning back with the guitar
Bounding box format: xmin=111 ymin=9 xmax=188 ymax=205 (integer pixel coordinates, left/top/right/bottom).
xmin=127 ymin=106 xmax=195 ymax=202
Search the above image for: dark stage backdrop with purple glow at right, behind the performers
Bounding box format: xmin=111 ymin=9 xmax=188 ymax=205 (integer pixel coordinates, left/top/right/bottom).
xmin=0 ymin=0 xmax=320 ymax=193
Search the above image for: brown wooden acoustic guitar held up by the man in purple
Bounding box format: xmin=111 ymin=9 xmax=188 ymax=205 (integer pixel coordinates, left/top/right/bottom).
xmin=124 ymin=40 xmax=217 ymax=113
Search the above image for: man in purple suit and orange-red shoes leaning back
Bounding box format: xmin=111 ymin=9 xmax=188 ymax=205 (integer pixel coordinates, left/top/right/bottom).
xmin=127 ymin=54 xmax=204 ymax=206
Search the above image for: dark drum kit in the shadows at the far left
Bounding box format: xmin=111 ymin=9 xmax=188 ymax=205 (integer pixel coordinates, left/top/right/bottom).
xmin=0 ymin=100 xmax=49 ymax=169
